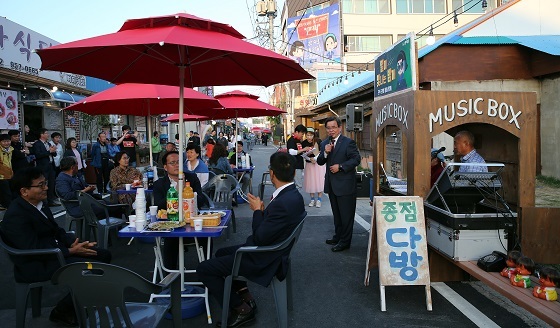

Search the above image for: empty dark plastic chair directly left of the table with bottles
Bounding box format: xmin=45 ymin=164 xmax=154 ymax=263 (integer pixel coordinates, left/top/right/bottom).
xmin=78 ymin=192 xmax=129 ymax=249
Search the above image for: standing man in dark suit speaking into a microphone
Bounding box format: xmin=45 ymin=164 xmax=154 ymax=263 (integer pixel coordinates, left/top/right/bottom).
xmin=317 ymin=117 xmax=361 ymax=252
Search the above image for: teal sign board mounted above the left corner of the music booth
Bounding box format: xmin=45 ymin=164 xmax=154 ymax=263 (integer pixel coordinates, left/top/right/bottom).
xmin=374 ymin=33 xmax=416 ymax=98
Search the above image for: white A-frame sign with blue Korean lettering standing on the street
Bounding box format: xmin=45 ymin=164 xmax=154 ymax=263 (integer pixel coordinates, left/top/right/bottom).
xmin=372 ymin=196 xmax=432 ymax=311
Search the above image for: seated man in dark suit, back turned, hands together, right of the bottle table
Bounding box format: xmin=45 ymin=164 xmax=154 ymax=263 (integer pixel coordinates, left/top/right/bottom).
xmin=196 ymin=152 xmax=306 ymax=327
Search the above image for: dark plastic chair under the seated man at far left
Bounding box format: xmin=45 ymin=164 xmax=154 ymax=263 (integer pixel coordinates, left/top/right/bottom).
xmin=0 ymin=232 xmax=70 ymax=328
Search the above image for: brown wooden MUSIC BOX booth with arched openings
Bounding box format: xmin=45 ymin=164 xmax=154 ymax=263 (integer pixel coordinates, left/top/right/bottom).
xmin=370 ymin=90 xmax=537 ymax=281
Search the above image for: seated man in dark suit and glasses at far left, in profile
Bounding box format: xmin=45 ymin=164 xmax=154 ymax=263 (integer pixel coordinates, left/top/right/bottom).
xmin=0 ymin=167 xmax=111 ymax=325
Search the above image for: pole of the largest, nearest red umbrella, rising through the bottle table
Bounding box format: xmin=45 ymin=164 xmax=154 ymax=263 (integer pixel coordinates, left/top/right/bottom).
xmin=177 ymin=64 xmax=185 ymax=291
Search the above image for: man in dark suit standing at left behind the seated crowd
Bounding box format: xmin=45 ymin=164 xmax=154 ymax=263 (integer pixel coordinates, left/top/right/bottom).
xmin=31 ymin=128 xmax=60 ymax=206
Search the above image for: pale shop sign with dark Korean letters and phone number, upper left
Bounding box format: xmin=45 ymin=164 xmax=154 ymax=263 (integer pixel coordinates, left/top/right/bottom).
xmin=0 ymin=17 xmax=86 ymax=88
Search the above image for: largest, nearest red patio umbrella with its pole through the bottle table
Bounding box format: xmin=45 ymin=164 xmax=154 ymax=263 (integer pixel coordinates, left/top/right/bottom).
xmin=37 ymin=14 xmax=313 ymax=254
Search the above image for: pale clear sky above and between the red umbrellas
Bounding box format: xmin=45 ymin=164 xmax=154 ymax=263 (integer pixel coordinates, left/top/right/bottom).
xmin=0 ymin=0 xmax=284 ymax=100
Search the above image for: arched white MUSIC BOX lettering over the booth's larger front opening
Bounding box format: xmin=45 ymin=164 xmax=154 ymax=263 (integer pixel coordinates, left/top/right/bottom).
xmin=428 ymin=97 xmax=522 ymax=132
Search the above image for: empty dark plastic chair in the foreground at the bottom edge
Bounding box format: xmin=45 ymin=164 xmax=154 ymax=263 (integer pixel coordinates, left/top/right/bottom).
xmin=52 ymin=262 xmax=181 ymax=327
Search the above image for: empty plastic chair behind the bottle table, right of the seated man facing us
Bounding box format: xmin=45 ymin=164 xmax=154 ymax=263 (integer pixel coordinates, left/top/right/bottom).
xmin=202 ymin=174 xmax=240 ymax=232
